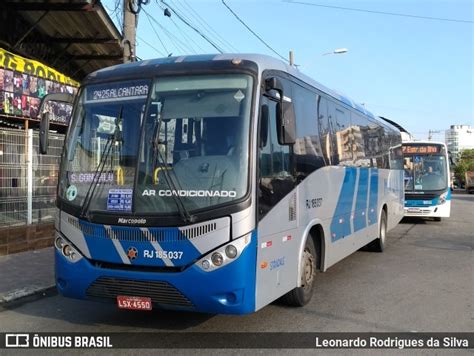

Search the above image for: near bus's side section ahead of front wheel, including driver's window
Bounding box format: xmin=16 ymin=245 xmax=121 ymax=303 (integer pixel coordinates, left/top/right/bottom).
xmin=256 ymin=97 xmax=297 ymax=309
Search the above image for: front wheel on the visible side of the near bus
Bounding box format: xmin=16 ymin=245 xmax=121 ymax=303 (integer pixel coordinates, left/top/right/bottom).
xmin=282 ymin=236 xmax=318 ymax=307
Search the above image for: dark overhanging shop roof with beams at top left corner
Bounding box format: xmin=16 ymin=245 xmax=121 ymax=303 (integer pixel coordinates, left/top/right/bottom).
xmin=0 ymin=0 xmax=123 ymax=81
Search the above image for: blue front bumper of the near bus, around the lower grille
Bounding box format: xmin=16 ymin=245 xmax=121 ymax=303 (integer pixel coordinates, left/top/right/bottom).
xmin=55 ymin=231 xmax=257 ymax=314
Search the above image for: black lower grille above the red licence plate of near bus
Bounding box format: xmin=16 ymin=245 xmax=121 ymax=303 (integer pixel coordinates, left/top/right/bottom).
xmin=86 ymin=277 xmax=193 ymax=307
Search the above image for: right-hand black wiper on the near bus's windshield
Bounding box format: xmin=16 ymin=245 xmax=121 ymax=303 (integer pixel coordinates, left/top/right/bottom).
xmin=152 ymin=102 xmax=196 ymax=223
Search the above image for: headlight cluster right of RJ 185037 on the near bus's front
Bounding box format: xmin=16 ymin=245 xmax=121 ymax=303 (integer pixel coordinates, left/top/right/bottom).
xmin=196 ymin=233 xmax=252 ymax=272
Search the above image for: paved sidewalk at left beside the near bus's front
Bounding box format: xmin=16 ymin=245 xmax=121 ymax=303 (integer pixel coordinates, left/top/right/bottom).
xmin=0 ymin=247 xmax=54 ymax=305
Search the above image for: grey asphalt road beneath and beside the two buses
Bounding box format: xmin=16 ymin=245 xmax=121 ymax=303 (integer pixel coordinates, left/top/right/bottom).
xmin=0 ymin=193 xmax=474 ymax=352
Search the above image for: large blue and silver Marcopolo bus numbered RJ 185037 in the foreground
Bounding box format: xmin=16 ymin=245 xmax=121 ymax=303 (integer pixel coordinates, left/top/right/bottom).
xmin=41 ymin=54 xmax=403 ymax=314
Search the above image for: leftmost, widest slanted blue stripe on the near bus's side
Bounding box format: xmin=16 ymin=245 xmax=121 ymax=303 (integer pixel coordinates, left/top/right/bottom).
xmin=331 ymin=168 xmax=357 ymax=242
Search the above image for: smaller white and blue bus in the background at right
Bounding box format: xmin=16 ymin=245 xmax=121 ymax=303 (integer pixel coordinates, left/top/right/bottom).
xmin=402 ymin=141 xmax=451 ymax=221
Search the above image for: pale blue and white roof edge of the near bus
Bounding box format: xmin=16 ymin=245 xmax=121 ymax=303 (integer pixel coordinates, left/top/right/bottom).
xmin=86 ymin=53 xmax=375 ymax=119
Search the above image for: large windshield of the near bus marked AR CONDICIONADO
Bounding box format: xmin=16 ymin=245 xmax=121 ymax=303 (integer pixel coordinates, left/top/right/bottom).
xmin=59 ymin=74 xmax=253 ymax=214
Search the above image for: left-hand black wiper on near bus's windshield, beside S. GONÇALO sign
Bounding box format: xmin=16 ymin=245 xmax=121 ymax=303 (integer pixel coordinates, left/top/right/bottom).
xmin=80 ymin=105 xmax=123 ymax=220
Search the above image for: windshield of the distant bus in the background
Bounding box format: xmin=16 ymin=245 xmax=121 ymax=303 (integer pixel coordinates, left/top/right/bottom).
xmin=404 ymin=154 xmax=448 ymax=191
